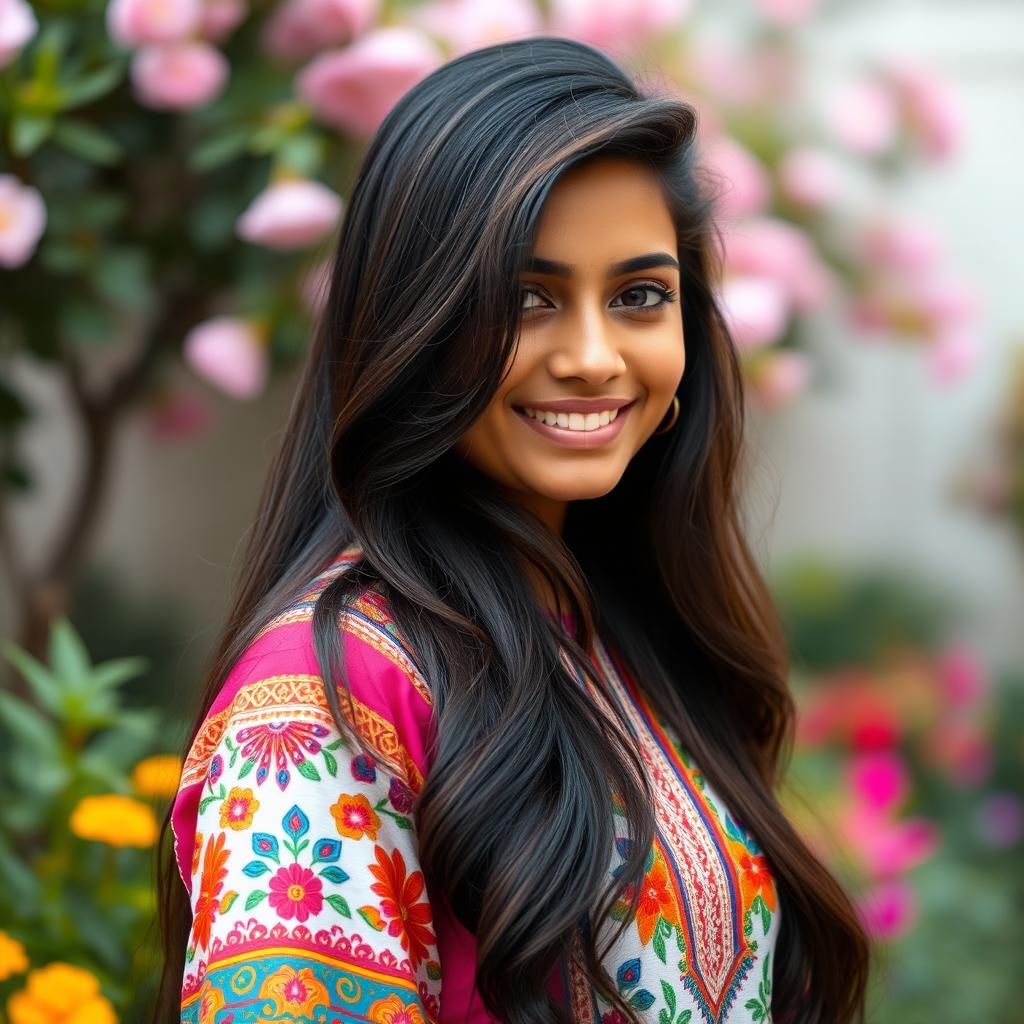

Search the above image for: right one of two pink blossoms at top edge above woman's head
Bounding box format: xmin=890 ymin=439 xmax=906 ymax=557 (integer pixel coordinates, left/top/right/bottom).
xmin=550 ymin=0 xmax=691 ymax=51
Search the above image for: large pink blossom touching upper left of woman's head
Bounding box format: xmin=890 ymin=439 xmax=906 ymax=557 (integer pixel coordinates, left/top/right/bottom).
xmin=296 ymin=28 xmax=441 ymax=137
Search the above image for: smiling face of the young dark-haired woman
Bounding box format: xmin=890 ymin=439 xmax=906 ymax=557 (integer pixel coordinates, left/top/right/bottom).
xmin=458 ymin=157 xmax=685 ymax=532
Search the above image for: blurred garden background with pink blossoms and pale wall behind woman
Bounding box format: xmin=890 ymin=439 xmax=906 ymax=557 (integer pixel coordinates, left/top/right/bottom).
xmin=0 ymin=0 xmax=1024 ymax=1024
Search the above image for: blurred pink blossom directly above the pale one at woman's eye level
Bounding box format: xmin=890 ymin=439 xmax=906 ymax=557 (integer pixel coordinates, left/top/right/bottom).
xmin=724 ymin=217 xmax=837 ymax=311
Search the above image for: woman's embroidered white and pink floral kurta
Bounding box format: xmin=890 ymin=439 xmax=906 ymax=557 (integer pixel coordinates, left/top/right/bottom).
xmin=171 ymin=547 xmax=780 ymax=1024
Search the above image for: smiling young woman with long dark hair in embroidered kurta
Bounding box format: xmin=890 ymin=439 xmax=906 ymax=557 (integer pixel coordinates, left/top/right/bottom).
xmin=153 ymin=38 xmax=868 ymax=1024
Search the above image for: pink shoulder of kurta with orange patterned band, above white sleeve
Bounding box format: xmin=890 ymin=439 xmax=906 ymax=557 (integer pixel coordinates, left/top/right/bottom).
xmin=181 ymin=547 xmax=432 ymax=792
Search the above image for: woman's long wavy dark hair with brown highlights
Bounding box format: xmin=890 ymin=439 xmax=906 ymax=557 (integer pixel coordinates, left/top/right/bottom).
xmin=158 ymin=37 xmax=869 ymax=1024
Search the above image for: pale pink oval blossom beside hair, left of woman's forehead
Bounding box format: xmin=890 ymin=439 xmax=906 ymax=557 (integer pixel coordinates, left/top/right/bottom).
xmin=238 ymin=179 xmax=341 ymax=249
